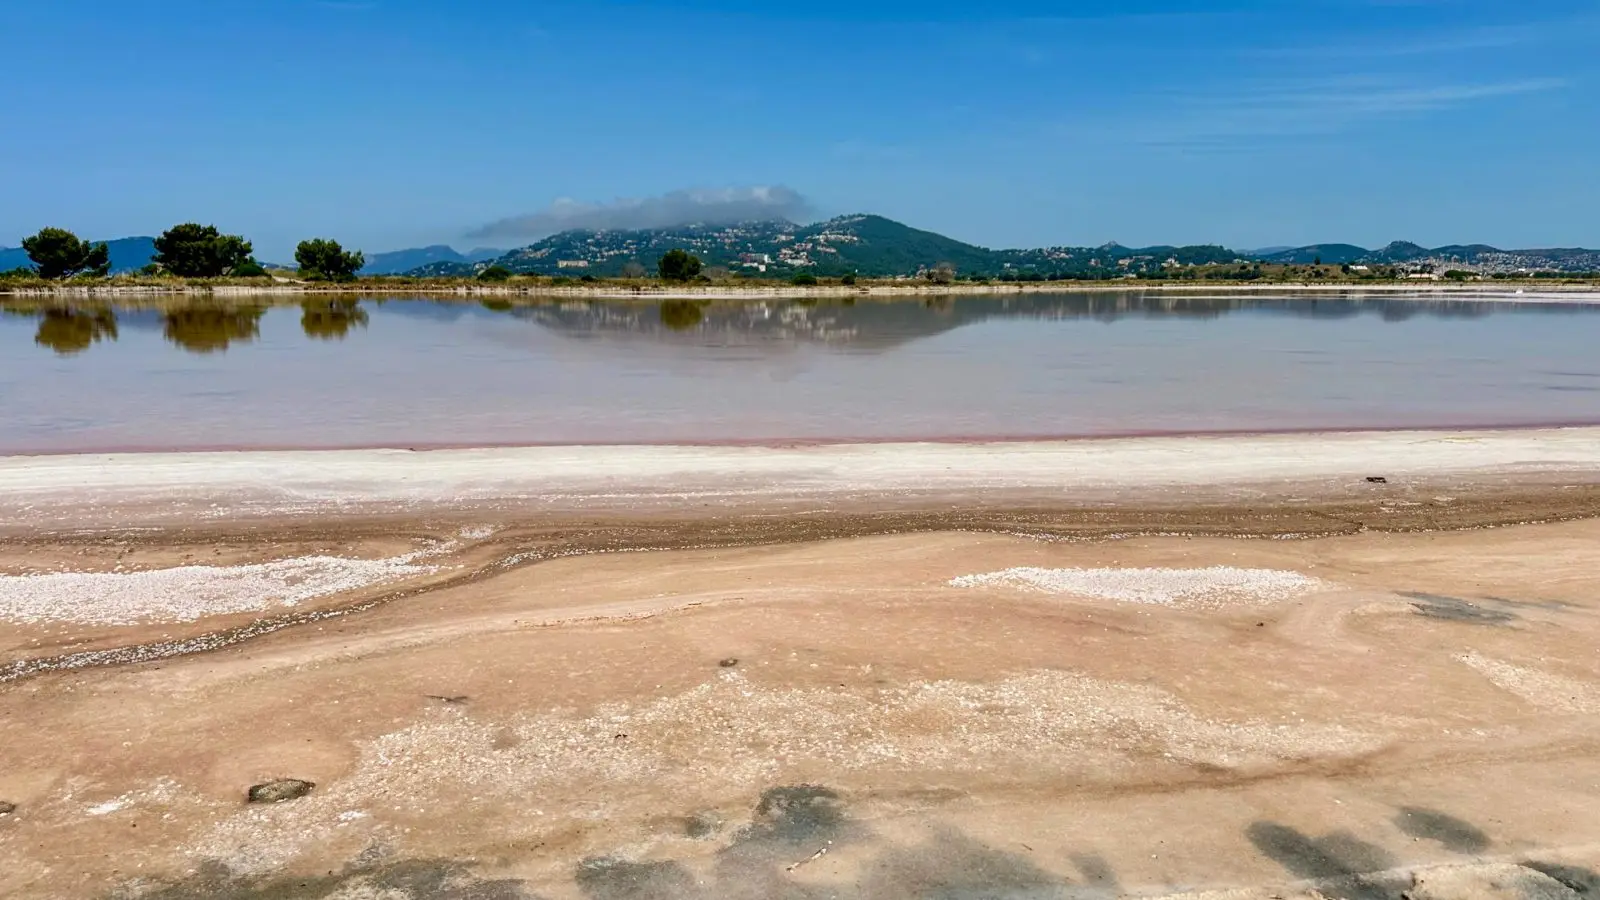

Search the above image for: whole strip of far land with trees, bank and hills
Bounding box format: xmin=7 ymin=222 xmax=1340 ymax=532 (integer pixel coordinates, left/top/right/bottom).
xmin=0 ymin=215 xmax=1600 ymax=293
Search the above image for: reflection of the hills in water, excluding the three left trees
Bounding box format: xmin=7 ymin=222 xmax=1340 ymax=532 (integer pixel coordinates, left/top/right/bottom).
xmin=493 ymin=291 xmax=1600 ymax=351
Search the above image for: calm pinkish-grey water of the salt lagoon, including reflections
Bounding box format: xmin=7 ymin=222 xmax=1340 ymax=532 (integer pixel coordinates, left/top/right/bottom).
xmin=0 ymin=291 xmax=1600 ymax=453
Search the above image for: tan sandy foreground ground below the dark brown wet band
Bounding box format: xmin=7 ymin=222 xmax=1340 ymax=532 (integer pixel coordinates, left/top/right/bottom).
xmin=0 ymin=509 xmax=1600 ymax=900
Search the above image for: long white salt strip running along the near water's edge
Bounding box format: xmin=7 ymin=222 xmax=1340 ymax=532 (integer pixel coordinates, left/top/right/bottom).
xmin=0 ymin=428 xmax=1600 ymax=524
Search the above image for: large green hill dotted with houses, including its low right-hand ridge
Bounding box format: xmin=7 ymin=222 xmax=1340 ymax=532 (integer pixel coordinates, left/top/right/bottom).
xmin=428 ymin=215 xmax=1238 ymax=277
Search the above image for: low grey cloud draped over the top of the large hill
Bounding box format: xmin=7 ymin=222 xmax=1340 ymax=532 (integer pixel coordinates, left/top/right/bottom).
xmin=467 ymin=186 xmax=811 ymax=240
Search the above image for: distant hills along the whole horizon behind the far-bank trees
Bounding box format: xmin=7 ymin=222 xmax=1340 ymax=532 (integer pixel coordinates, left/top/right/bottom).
xmin=9 ymin=215 xmax=1600 ymax=279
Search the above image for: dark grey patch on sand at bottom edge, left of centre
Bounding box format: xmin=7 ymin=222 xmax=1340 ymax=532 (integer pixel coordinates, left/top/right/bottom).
xmin=124 ymin=860 xmax=539 ymax=900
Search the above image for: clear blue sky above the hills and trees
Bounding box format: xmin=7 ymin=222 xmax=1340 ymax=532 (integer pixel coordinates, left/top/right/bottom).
xmin=0 ymin=0 xmax=1600 ymax=259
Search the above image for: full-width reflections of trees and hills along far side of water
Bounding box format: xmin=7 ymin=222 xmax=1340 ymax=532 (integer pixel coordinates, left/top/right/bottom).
xmin=0 ymin=291 xmax=1600 ymax=356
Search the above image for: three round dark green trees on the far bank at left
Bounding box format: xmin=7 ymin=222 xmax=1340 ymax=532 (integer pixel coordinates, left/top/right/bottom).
xmin=10 ymin=223 xmax=366 ymax=282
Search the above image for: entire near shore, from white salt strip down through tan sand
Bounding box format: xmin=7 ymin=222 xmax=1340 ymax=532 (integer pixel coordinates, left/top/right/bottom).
xmin=0 ymin=429 xmax=1600 ymax=898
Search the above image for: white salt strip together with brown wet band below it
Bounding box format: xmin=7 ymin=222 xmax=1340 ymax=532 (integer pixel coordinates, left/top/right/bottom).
xmin=0 ymin=428 xmax=1600 ymax=533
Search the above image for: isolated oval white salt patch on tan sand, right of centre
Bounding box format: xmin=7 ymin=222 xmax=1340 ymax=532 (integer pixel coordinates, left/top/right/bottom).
xmin=950 ymin=565 xmax=1323 ymax=609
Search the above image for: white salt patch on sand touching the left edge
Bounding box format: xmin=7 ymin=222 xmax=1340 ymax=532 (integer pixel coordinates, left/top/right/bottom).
xmin=0 ymin=554 xmax=437 ymax=625
